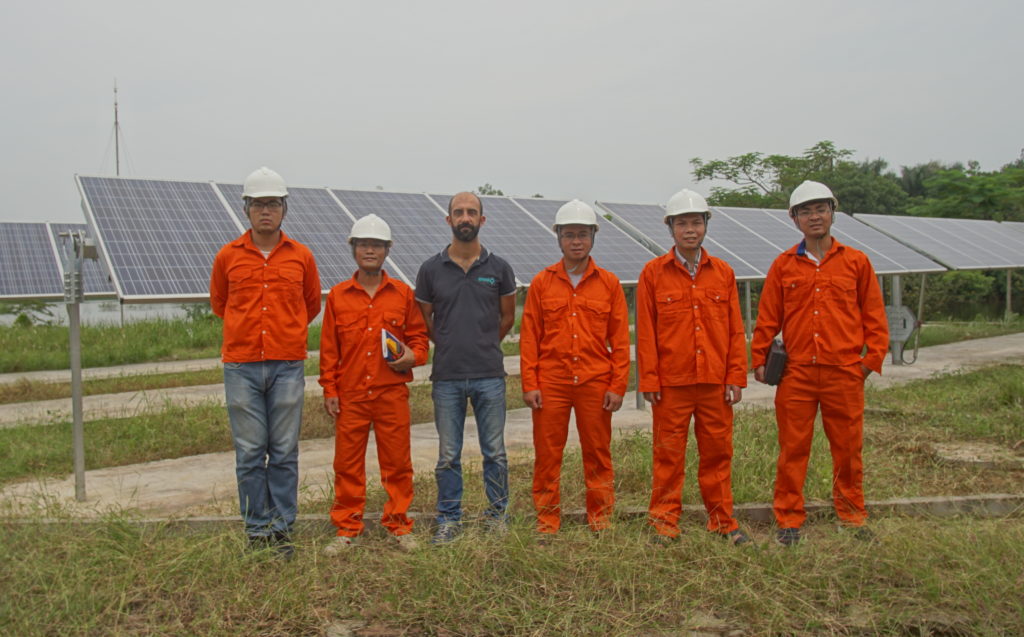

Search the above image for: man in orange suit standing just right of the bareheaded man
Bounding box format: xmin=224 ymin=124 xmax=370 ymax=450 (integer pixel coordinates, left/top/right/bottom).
xmin=519 ymin=200 xmax=630 ymax=540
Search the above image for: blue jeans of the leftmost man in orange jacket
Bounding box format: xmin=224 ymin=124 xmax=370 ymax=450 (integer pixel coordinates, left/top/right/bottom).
xmin=224 ymin=360 xmax=305 ymax=536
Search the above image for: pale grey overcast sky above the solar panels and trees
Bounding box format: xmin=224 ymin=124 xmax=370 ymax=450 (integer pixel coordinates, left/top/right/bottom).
xmin=0 ymin=0 xmax=1024 ymax=226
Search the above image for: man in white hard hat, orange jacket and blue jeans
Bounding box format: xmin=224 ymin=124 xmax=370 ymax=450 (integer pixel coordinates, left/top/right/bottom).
xmin=210 ymin=167 xmax=321 ymax=556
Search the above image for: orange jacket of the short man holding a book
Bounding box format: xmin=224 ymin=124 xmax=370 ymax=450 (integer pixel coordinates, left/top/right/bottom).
xmin=319 ymin=271 xmax=430 ymax=401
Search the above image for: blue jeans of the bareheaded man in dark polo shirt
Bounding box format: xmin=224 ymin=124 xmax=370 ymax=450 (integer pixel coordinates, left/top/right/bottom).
xmin=431 ymin=378 xmax=509 ymax=524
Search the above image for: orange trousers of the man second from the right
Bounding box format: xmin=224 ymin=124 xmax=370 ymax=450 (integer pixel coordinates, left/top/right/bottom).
xmin=648 ymin=383 xmax=739 ymax=538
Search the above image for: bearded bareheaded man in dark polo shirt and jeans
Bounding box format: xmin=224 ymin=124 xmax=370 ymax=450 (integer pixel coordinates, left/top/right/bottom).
xmin=416 ymin=193 xmax=516 ymax=545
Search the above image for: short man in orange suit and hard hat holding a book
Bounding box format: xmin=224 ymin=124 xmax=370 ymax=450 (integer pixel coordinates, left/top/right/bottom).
xmin=319 ymin=214 xmax=430 ymax=555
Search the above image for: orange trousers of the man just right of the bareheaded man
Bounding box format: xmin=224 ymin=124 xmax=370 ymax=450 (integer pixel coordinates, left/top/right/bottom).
xmin=532 ymin=380 xmax=615 ymax=534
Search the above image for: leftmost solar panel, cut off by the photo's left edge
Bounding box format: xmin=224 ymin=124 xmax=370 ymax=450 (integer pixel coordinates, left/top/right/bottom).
xmin=0 ymin=223 xmax=63 ymax=300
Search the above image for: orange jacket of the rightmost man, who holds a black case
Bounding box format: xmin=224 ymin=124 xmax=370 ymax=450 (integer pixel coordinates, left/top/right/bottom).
xmin=751 ymin=239 xmax=889 ymax=374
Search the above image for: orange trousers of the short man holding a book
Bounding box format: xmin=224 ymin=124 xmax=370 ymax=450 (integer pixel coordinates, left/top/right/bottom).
xmin=331 ymin=384 xmax=413 ymax=538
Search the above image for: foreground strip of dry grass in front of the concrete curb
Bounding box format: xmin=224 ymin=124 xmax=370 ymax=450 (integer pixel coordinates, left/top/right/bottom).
xmin=0 ymin=516 xmax=1024 ymax=636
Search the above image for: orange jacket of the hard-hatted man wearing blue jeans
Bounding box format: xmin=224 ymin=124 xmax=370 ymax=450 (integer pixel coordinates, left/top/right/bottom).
xmin=210 ymin=230 xmax=321 ymax=363
